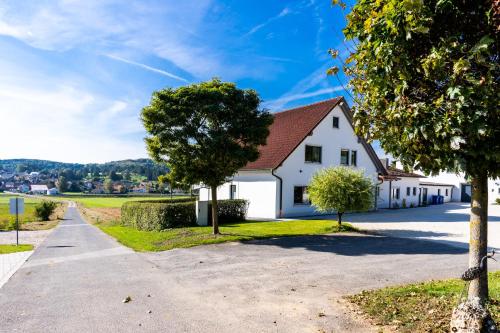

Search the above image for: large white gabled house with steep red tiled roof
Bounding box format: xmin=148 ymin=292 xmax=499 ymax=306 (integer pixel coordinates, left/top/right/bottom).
xmin=200 ymin=97 xmax=386 ymax=219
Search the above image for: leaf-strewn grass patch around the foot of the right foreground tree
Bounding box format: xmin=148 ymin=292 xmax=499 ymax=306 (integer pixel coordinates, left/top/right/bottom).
xmin=347 ymin=271 xmax=500 ymax=332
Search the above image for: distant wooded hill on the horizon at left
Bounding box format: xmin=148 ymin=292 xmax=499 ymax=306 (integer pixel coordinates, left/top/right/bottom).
xmin=0 ymin=158 xmax=168 ymax=180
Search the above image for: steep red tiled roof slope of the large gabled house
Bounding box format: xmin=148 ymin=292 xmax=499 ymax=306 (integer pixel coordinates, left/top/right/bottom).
xmin=243 ymin=97 xmax=342 ymax=170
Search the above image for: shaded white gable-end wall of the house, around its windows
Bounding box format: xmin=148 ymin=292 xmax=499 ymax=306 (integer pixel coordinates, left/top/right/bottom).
xmin=275 ymin=106 xmax=378 ymax=217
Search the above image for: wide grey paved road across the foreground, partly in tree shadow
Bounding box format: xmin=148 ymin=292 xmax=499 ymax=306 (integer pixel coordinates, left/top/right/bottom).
xmin=0 ymin=207 xmax=500 ymax=332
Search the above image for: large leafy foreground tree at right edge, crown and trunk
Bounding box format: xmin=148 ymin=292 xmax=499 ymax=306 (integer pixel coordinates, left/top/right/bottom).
xmin=329 ymin=0 xmax=500 ymax=302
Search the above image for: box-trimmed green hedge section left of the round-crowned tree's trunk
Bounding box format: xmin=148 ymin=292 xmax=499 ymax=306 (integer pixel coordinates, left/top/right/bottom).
xmin=121 ymin=199 xmax=196 ymax=231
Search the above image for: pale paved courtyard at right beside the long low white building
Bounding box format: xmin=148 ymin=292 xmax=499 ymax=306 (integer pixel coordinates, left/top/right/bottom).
xmin=344 ymin=202 xmax=500 ymax=249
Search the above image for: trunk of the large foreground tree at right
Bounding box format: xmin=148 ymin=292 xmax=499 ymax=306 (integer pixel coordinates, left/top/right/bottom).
xmin=469 ymin=172 xmax=488 ymax=304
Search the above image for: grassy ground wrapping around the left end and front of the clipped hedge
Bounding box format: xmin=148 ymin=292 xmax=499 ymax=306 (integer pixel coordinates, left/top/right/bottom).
xmin=75 ymin=197 xmax=355 ymax=251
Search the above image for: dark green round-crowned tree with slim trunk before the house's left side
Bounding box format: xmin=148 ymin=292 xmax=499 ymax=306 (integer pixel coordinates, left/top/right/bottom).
xmin=142 ymin=79 xmax=273 ymax=234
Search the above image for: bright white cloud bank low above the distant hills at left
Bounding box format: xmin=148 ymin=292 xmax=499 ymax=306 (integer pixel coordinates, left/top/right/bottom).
xmin=0 ymin=76 xmax=147 ymax=162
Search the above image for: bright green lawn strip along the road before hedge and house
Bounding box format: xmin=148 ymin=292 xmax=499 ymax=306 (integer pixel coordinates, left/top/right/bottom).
xmin=97 ymin=220 xmax=356 ymax=251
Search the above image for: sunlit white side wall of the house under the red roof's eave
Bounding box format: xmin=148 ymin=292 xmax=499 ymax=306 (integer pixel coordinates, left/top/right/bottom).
xmin=200 ymin=171 xmax=278 ymax=219
